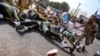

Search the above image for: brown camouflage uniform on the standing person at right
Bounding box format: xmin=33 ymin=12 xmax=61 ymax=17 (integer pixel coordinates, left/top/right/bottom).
xmin=84 ymin=22 xmax=97 ymax=45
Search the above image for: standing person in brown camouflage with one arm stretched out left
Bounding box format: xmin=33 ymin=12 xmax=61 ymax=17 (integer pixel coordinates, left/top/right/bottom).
xmin=77 ymin=15 xmax=98 ymax=45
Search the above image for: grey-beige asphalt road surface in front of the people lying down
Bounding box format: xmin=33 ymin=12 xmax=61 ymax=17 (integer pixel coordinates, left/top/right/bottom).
xmin=0 ymin=24 xmax=100 ymax=56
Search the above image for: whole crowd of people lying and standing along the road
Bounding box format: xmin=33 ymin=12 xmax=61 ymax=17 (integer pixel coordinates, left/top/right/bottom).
xmin=0 ymin=0 xmax=98 ymax=55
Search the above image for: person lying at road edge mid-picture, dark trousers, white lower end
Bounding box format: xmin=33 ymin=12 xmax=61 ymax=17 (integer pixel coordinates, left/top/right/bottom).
xmin=42 ymin=22 xmax=69 ymax=48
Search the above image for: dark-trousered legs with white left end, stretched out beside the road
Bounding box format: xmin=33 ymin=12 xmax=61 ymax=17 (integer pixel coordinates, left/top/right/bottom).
xmin=15 ymin=21 xmax=39 ymax=31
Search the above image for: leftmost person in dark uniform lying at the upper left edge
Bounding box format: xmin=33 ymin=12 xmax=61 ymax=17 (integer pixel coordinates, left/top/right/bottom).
xmin=0 ymin=2 xmax=20 ymax=22
